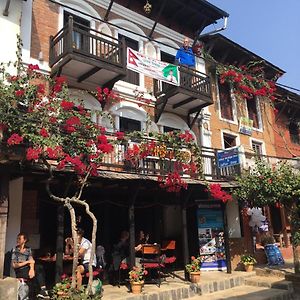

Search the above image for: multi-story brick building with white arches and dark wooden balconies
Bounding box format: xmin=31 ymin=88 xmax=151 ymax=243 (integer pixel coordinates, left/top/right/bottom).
xmin=1 ymin=0 xmax=298 ymax=284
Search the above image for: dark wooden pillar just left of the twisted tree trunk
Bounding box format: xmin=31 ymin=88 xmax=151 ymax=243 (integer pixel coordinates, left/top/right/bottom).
xmin=55 ymin=204 xmax=65 ymax=283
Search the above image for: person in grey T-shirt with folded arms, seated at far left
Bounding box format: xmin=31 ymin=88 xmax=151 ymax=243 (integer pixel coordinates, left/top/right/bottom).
xmin=11 ymin=232 xmax=50 ymax=299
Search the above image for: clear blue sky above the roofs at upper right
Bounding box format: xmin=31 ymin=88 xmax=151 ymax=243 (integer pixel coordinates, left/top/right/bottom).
xmin=208 ymin=0 xmax=300 ymax=93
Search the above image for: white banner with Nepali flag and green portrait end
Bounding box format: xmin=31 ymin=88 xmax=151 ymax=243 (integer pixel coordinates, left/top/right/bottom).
xmin=127 ymin=47 xmax=180 ymax=86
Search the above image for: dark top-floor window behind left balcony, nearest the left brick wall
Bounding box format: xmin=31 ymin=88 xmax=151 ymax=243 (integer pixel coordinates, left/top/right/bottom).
xmin=64 ymin=11 xmax=91 ymax=52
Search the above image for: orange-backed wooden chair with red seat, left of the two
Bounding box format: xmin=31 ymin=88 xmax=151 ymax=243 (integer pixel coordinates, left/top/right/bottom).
xmin=140 ymin=244 xmax=165 ymax=287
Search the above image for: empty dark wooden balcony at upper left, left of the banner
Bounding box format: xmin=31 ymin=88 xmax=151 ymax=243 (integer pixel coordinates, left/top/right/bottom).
xmin=49 ymin=17 xmax=126 ymax=88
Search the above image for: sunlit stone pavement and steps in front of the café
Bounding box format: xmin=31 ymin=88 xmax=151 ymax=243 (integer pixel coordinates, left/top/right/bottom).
xmin=103 ymin=261 xmax=300 ymax=300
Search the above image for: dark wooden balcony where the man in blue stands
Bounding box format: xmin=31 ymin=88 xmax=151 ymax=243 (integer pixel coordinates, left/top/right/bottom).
xmin=154 ymin=66 xmax=213 ymax=127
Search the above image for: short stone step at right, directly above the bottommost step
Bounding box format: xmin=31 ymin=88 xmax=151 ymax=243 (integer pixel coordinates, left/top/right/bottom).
xmin=245 ymin=276 xmax=293 ymax=293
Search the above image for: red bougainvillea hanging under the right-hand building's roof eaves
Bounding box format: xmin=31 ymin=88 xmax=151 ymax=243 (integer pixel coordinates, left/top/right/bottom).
xmin=217 ymin=61 xmax=277 ymax=103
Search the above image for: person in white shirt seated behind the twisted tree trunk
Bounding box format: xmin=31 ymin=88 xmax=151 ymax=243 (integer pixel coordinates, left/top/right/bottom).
xmin=76 ymin=228 xmax=97 ymax=289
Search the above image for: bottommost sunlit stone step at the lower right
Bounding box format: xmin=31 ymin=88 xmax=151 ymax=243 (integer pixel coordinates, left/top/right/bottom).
xmin=190 ymin=286 xmax=293 ymax=300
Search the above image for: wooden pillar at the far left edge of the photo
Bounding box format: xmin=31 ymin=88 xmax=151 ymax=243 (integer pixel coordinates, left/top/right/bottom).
xmin=0 ymin=175 xmax=9 ymax=279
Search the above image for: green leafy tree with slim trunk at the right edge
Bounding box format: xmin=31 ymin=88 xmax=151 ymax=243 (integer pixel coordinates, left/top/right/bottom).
xmin=233 ymin=160 xmax=300 ymax=273
